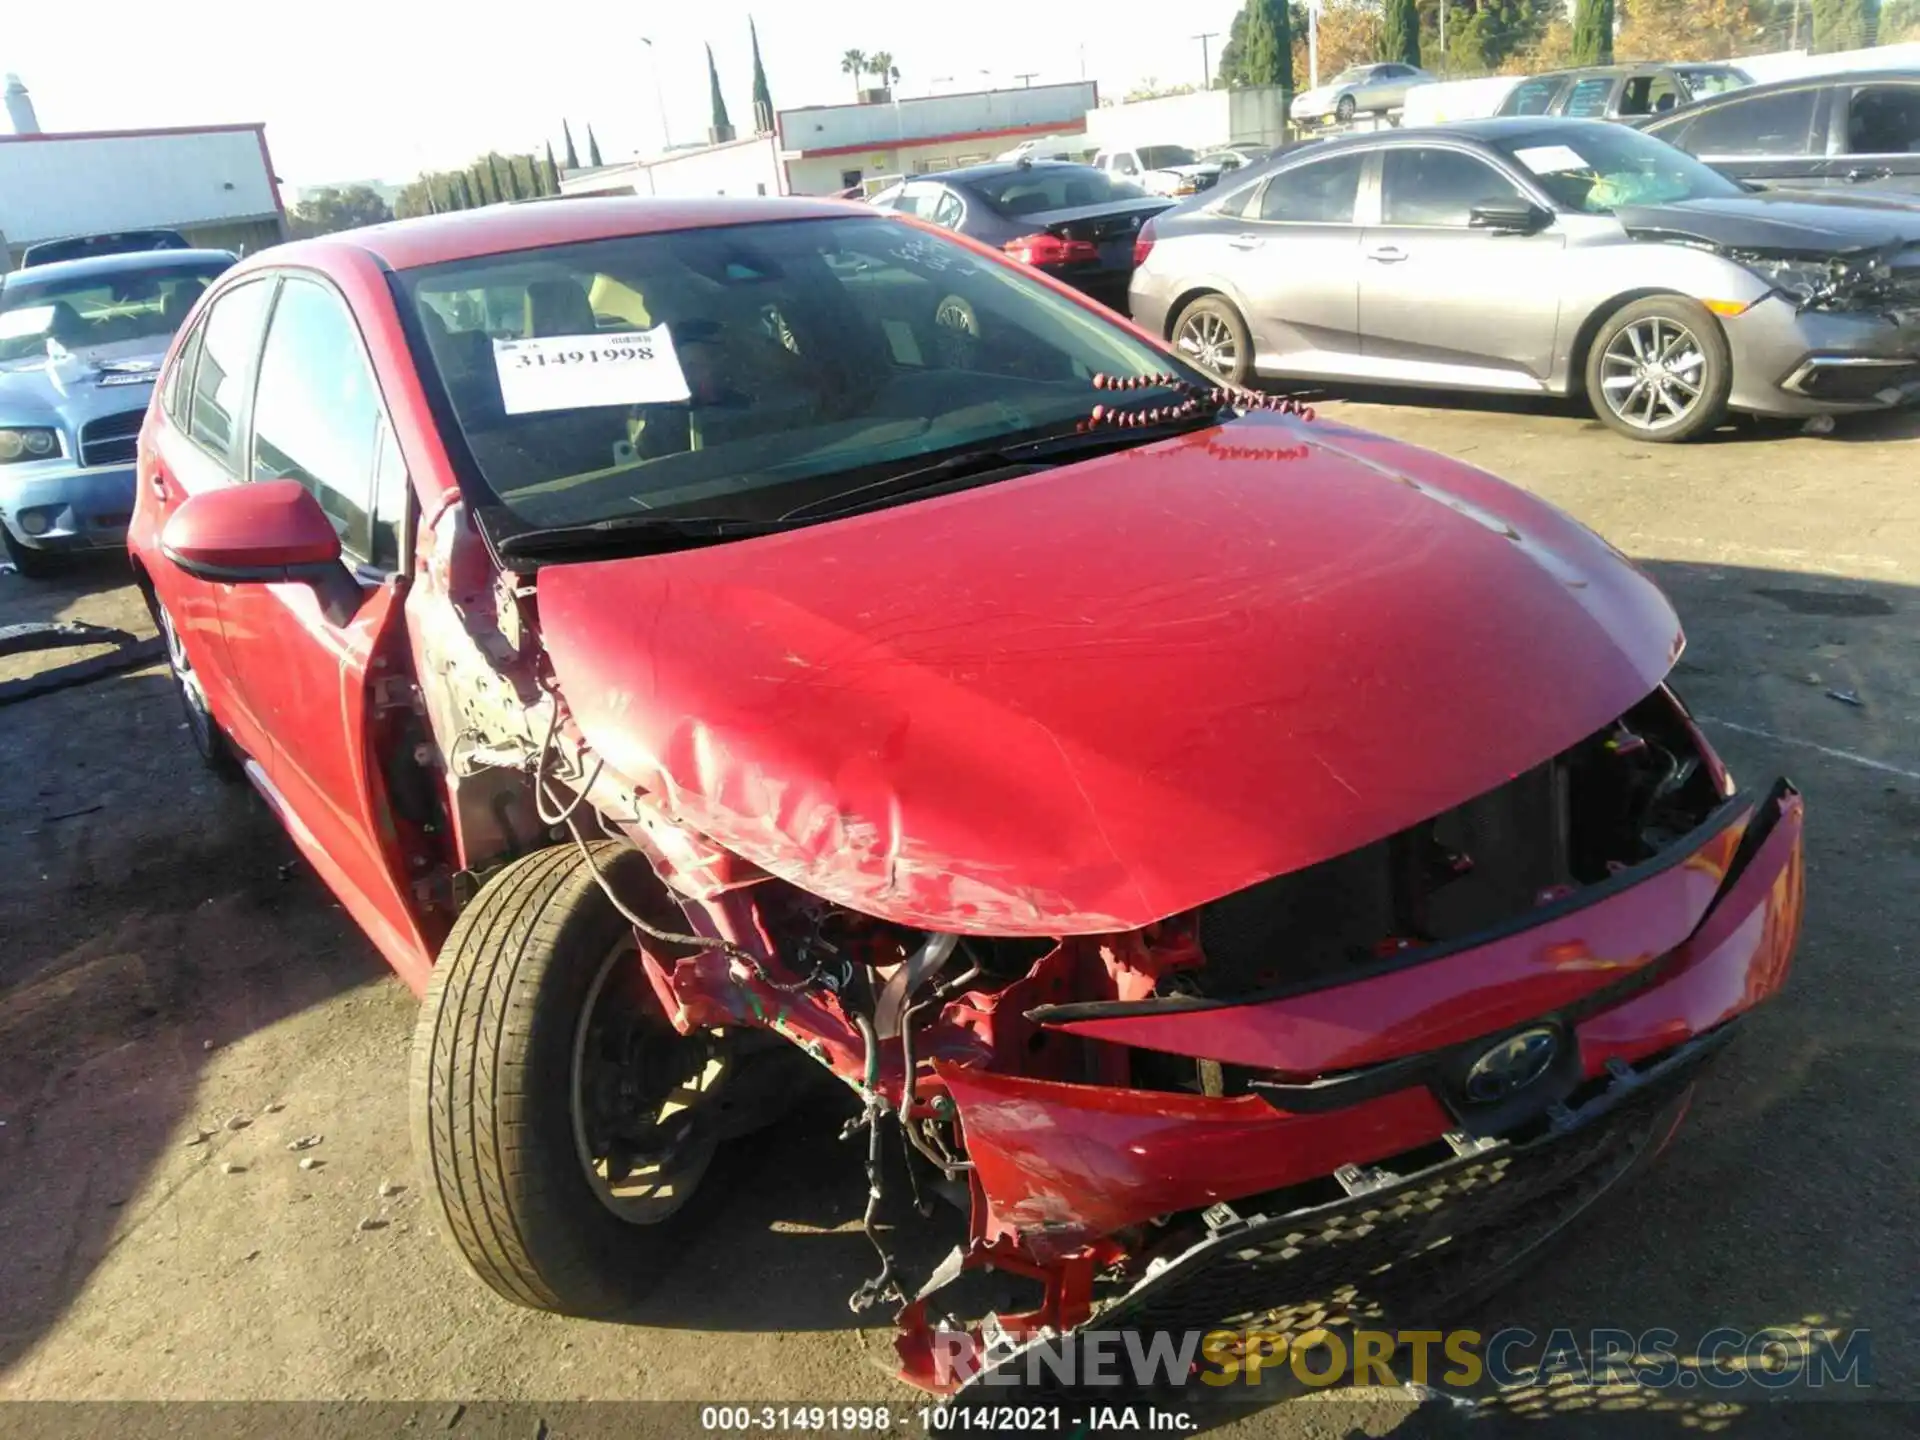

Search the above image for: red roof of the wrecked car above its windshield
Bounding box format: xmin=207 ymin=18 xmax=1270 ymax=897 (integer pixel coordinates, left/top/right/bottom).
xmin=284 ymin=196 xmax=874 ymax=271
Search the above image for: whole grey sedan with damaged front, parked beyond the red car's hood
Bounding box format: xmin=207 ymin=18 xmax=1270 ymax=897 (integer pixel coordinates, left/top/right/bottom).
xmin=1131 ymin=119 xmax=1920 ymax=440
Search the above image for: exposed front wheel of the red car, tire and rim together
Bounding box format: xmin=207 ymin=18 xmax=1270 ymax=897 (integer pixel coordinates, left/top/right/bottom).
xmin=411 ymin=843 xmax=728 ymax=1317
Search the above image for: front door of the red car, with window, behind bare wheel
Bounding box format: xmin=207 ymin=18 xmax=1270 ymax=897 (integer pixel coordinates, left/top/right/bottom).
xmin=221 ymin=273 xmax=430 ymax=975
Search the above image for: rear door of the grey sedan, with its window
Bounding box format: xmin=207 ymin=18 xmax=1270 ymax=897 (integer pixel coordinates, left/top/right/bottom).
xmin=1217 ymin=150 xmax=1375 ymax=374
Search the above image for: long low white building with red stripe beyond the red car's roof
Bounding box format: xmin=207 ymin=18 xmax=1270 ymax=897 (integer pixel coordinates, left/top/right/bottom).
xmin=561 ymin=81 xmax=1100 ymax=196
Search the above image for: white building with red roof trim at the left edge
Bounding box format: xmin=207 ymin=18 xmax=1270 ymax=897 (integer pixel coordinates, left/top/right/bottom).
xmin=0 ymin=125 xmax=286 ymax=271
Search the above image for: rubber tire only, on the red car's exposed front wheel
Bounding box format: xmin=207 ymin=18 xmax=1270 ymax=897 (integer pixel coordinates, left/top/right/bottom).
xmin=411 ymin=843 xmax=725 ymax=1317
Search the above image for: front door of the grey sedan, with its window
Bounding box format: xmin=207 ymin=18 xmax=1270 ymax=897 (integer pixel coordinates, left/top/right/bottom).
xmin=1359 ymin=146 xmax=1567 ymax=390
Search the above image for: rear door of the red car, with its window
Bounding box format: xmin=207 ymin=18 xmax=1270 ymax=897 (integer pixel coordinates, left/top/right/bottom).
xmin=140 ymin=276 xmax=273 ymax=758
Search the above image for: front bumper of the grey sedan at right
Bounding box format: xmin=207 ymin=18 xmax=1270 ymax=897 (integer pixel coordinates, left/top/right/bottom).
xmin=1724 ymin=296 xmax=1920 ymax=415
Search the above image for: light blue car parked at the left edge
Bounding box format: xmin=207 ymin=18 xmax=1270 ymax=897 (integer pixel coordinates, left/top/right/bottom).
xmin=0 ymin=250 xmax=234 ymax=576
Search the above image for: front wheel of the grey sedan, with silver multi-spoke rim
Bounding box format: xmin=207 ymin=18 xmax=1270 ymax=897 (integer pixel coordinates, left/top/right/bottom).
xmin=1586 ymin=296 xmax=1734 ymax=444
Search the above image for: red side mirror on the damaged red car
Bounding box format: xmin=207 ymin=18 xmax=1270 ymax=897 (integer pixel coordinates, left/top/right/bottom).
xmin=159 ymin=480 xmax=340 ymax=586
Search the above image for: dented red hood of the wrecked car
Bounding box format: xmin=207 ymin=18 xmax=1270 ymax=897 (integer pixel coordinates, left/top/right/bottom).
xmin=540 ymin=417 xmax=1680 ymax=935
